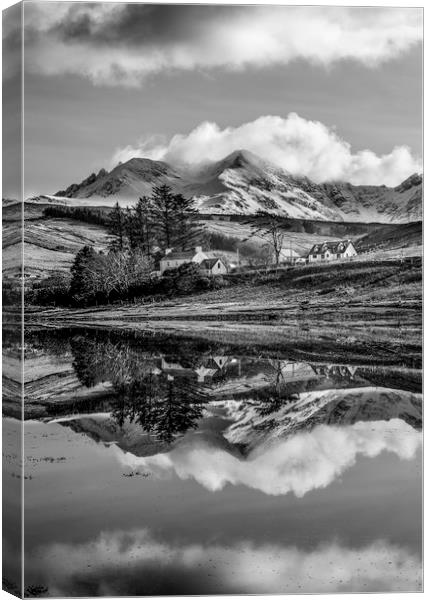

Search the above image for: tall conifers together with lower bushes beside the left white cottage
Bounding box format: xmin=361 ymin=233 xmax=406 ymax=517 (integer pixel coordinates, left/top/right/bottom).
xmin=70 ymin=185 xmax=207 ymax=305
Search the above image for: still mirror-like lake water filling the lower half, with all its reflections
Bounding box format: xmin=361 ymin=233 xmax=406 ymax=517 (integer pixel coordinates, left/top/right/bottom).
xmin=5 ymin=331 xmax=422 ymax=597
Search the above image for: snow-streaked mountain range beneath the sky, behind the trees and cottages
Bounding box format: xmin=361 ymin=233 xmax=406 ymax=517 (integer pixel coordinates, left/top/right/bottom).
xmin=55 ymin=150 xmax=422 ymax=223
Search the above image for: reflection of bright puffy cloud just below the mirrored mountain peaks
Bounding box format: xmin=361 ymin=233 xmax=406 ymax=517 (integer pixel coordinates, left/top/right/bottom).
xmin=118 ymin=419 xmax=422 ymax=496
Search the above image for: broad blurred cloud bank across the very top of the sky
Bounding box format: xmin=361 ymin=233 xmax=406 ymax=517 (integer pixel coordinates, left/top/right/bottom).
xmin=20 ymin=3 xmax=423 ymax=86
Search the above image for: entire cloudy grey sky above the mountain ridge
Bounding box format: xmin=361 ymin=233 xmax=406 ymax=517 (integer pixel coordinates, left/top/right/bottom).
xmin=3 ymin=1 xmax=423 ymax=196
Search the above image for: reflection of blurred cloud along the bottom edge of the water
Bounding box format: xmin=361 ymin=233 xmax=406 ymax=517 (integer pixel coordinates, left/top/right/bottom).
xmin=26 ymin=529 xmax=421 ymax=596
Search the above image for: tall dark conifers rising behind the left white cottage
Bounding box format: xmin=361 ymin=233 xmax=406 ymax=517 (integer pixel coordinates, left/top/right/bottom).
xmin=108 ymin=185 xmax=202 ymax=256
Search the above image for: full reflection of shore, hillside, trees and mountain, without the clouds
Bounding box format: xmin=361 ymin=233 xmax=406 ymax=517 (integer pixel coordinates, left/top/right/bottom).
xmin=6 ymin=332 xmax=422 ymax=456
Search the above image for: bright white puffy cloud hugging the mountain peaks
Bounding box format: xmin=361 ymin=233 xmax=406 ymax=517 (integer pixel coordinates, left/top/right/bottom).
xmin=112 ymin=113 xmax=422 ymax=186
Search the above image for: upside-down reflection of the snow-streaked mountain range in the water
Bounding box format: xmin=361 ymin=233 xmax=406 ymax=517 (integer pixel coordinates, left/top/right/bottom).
xmin=55 ymin=388 xmax=422 ymax=456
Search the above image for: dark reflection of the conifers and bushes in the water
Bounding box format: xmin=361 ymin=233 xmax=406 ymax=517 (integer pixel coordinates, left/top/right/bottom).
xmin=72 ymin=338 xmax=206 ymax=443
